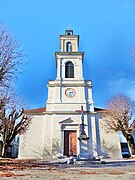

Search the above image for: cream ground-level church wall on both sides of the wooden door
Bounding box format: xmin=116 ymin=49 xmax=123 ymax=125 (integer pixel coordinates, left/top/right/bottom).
xmin=19 ymin=112 xmax=121 ymax=158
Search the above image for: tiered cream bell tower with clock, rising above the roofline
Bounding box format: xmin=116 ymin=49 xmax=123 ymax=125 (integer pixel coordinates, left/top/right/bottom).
xmin=46 ymin=29 xmax=94 ymax=112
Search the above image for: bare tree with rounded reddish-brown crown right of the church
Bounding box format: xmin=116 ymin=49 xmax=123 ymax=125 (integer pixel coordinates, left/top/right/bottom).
xmin=105 ymin=94 xmax=135 ymax=155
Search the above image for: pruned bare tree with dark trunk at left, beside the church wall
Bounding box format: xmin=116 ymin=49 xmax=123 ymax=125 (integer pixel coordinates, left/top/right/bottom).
xmin=0 ymin=96 xmax=31 ymax=157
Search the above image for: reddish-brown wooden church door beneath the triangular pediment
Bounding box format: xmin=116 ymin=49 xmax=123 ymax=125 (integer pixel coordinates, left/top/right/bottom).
xmin=64 ymin=131 xmax=77 ymax=156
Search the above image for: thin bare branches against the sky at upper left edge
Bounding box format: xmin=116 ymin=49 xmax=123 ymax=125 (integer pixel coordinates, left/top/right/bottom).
xmin=0 ymin=24 xmax=24 ymax=86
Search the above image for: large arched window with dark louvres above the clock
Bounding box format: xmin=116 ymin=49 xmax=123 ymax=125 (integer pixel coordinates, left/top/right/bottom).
xmin=65 ymin=62 xmax=74 ymax=78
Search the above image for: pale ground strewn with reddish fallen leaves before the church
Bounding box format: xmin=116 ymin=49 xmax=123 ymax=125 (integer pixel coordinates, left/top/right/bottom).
xmin=0 ymin=159 xmax=135 ymax=180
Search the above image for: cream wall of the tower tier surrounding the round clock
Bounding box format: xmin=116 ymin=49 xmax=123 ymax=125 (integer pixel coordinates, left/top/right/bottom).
xmin=46 ymin=80 xmax=94 ymax=111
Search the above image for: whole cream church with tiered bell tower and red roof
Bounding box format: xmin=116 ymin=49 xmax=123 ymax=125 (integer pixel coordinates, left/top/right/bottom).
xmin=18 ymin=29 xmax=121 ymax=159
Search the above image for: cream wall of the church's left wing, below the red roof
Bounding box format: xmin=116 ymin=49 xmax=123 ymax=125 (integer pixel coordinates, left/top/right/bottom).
xmin=18 ymin=115 xmax=45 ymax=159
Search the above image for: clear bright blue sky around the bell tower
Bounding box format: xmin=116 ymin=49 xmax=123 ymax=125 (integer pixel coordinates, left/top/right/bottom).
xmin=0 ymin=0 xmax=135 ymax=108
